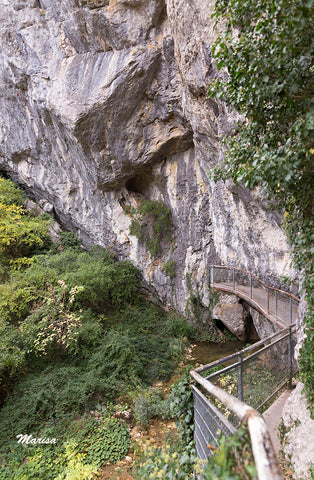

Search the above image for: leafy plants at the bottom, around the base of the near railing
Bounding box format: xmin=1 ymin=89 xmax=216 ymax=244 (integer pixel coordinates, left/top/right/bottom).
xmin=136 ymin=372 xmax=256 ymax=480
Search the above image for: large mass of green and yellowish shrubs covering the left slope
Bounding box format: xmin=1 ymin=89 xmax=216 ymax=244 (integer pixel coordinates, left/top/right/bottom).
xmin=0 ymin=179 xmax=197 ymax=480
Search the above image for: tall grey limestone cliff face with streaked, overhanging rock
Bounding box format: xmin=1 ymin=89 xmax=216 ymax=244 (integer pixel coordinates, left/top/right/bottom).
xmin=0 ymin=0 xmax=289 ymax=312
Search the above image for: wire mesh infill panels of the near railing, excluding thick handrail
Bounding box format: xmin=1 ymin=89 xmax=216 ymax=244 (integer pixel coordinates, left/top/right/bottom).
xmin=194 ymin=325 xmax=298 ymax=446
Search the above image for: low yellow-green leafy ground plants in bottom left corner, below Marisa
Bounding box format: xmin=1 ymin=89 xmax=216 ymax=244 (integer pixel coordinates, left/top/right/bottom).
xmin=0 ymin=406 xmax=130 ymax=480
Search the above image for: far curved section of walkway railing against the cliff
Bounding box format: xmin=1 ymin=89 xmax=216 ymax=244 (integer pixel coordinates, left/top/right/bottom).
xmin=210 ymin=265 xmax=300 ymax=328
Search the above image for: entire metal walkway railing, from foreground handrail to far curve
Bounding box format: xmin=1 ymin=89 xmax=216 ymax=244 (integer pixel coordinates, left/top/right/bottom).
xmin=191 ymin=266 xmax=299 ymax=480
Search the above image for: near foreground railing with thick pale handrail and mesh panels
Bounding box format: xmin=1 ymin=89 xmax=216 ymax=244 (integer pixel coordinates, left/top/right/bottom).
xmin=191 ymin=325 xmax=297 ymax=480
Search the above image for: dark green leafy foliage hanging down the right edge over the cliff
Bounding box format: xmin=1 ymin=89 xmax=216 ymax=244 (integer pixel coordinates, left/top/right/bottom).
xmin=209 ymin=0 xmax=314 ymax=414
